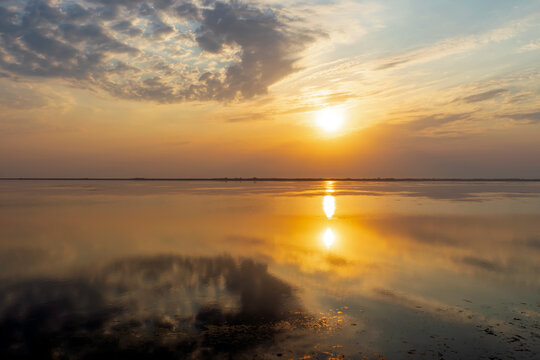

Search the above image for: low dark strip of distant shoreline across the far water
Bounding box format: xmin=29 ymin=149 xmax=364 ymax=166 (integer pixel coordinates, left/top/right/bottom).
xmin=0 ymin=177 xmax=540 ymax=182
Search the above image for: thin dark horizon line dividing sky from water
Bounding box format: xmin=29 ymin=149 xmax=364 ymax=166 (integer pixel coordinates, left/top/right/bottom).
xmin=0 ymin=177 xmax=540 ymax=182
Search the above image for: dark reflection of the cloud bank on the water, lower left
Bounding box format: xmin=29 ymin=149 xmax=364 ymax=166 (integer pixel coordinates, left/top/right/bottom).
xmin=0 ymin=256 xmax=305 ymax=359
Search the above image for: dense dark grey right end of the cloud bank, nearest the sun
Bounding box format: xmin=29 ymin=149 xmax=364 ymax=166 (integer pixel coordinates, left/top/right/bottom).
xmin=189 ymin=2 xmax=313 ymax=99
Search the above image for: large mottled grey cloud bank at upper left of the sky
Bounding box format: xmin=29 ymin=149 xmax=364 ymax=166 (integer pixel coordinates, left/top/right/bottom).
xmin=0 ymin=0 xmax=319 ymax=103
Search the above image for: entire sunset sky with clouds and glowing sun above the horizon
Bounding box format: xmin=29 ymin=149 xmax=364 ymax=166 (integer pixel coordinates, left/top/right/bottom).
xmin=0 ymin=0 xmax=540 ymax=178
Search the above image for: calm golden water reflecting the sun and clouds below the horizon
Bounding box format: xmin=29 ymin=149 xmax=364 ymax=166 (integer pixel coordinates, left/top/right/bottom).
xmin=0 ymin=181 xmax=540 ymax=359
